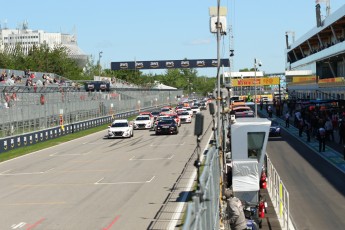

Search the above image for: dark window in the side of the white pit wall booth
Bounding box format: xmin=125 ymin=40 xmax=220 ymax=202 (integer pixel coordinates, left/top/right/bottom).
xmin=247 ymin=132 xmax=266 ymax=160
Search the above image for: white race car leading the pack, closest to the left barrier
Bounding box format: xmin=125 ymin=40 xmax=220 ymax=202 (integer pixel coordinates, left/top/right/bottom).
xmin=108 ymin=119 xmax=133 ymax=138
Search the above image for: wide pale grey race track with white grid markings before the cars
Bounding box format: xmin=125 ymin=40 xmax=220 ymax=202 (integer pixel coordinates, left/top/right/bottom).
xmin=0 ymin=111 xmax=212 ymax=230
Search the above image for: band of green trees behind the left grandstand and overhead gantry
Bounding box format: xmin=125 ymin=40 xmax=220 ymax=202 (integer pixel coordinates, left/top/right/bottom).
xmin=0 ymin=47 xmax=216 ymax=95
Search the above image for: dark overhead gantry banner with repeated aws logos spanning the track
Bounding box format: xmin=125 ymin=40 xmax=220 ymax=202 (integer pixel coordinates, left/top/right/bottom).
xmin=111 ymin=59 xmax=229 ymax=70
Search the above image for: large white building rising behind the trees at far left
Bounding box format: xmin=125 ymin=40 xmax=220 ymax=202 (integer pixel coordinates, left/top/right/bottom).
xmin=0 ymin=22 xmax=88 ymax=67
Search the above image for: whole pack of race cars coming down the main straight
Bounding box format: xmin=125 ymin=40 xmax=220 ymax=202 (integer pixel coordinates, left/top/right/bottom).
xmin=106 ymin=100 xmax=209 ymax=138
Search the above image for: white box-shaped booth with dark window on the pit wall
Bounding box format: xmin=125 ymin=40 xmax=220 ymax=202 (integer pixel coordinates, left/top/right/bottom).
xmin=231 ymin=118 xmax=271 ymax=202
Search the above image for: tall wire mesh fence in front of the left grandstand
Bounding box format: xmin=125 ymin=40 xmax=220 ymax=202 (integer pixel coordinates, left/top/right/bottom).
xmin=0 ymin=86 xmax=182 ymax=153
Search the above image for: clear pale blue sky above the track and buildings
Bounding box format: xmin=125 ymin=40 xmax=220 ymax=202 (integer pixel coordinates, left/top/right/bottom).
xmin=0 ymin=0 xmax=345 ymax=77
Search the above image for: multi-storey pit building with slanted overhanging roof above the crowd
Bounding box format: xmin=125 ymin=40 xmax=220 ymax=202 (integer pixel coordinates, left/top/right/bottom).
xmin=285 ymin=1 xmax=345 ymax=100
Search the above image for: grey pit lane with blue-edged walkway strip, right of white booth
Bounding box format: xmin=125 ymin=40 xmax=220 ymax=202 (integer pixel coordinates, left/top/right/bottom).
xmin=260 ymin=110 xmax=345 ymax=230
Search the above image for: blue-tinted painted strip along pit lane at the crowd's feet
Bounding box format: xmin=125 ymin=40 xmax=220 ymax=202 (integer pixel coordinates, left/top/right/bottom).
xmin=258 ymin=109 xmax=345 ymax=173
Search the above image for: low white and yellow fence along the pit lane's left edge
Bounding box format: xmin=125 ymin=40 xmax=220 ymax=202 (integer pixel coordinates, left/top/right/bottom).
xmin=266 ymin=155 xmax=296 ymax=230
